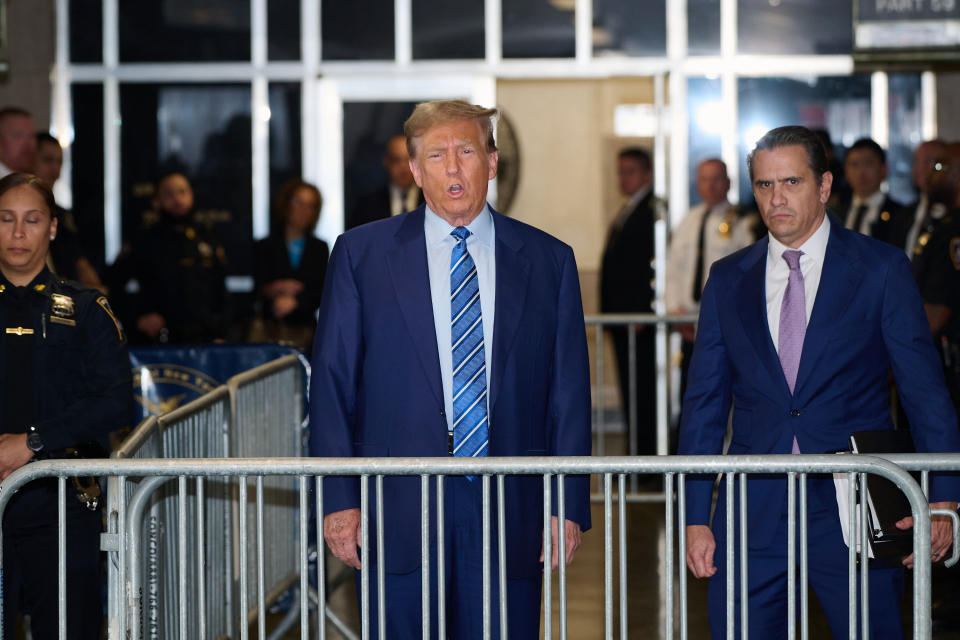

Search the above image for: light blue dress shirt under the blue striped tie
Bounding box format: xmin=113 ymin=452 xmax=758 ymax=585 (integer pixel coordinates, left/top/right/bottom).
xmin=423 ymin=205 xmax=497 ymax=430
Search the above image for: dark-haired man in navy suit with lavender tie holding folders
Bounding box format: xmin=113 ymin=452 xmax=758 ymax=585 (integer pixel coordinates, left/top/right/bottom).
xmin=679 ymin=127 xmax=960 ymax=638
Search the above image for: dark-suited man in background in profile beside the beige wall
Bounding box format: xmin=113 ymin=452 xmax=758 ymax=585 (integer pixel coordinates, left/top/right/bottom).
xmin=600 ymin=147 xmax=657 ymax=455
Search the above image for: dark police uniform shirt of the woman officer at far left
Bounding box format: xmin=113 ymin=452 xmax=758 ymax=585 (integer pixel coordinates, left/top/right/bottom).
xmin=0 ymin=269 xmax=133 ymax=452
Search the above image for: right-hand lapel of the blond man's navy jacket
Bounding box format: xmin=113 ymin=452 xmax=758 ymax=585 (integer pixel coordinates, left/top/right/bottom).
xmin=490 ymin=214 xmax=530 ymax=411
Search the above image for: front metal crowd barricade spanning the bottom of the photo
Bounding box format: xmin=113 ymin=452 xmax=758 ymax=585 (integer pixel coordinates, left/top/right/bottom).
xmin=0 ymin=454 xmax=960 ymax=640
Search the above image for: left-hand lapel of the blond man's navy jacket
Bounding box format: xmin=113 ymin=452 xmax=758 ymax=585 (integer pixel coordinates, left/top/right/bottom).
xmin=386 ymin=207 xmax=443 ymax=405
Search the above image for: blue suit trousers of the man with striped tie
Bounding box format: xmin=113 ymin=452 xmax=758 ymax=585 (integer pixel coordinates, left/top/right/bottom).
xmin=355 ymin=476 xmax=543 ymax=640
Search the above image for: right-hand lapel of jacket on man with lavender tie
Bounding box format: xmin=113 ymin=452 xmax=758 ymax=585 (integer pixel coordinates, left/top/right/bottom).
xmin=794 ymin=218 xmax=863 ymax=395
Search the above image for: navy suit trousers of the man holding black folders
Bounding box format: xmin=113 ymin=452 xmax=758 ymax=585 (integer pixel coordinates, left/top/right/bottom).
xmin=707 ymin=476 xmax=904 ymax=640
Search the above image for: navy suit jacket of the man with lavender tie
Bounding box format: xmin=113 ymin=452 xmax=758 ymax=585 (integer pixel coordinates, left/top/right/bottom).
xmin=679 ymin=218 xmax=960 ymax=547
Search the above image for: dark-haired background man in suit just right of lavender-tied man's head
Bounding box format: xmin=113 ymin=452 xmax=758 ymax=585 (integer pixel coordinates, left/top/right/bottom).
xmin=843 ymin=138 xmax=906 ymax=247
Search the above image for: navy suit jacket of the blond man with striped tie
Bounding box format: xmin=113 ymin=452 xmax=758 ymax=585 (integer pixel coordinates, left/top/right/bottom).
xmin=310 ymin=207 xmax=590 ymax=576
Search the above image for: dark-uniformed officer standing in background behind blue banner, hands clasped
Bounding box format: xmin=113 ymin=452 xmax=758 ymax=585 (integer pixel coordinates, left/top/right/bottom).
xmin=113 ymin=173 xmax=226 ymax=344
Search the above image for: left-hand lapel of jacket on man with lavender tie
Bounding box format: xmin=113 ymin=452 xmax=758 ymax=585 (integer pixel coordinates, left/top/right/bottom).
xmin=736 ymin=237 xmax=790 ymax=396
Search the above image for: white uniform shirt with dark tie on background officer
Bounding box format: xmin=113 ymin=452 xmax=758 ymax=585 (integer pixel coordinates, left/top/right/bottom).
xmin=665 ymin=200 xmax=755 ymax=311
